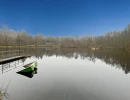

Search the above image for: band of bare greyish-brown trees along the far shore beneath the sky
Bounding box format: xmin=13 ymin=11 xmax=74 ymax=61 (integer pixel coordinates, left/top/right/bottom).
xmin=0 ymin=25 xmax=130 ymax=49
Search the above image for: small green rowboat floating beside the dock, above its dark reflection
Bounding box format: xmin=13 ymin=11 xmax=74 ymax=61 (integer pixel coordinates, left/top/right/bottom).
xmin=20 ymin=61 xmax=38 ymax=72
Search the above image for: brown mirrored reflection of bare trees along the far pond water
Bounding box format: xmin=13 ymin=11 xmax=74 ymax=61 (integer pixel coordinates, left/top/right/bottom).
xmin=23 ymin=49 xmax=130 ymax=74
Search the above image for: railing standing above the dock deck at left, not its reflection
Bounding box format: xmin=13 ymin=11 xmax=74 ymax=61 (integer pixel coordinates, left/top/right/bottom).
xmin=0 ymin=50 xmax=24 ymax=61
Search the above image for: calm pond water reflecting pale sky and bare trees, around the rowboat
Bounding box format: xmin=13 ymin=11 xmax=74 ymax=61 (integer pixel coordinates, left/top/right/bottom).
xmin=0 ymin=49 xmax=130 ymax=100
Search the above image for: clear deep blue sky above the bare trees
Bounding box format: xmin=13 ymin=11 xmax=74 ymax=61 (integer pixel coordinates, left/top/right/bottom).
xmin=0 ymin=0 xmax=130 ymax=36
